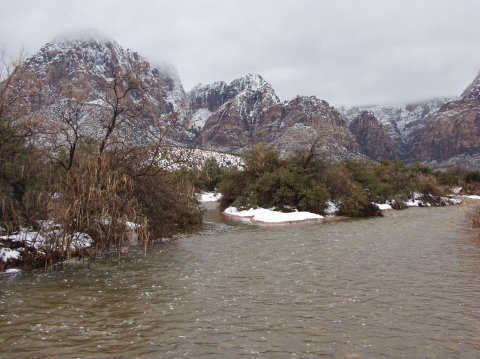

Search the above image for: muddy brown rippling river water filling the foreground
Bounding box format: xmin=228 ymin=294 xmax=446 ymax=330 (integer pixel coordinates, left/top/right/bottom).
xmin=0 ymin=205 xmax=480 ymax=359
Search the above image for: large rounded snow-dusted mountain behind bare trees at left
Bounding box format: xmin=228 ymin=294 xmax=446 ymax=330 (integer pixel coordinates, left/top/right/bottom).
xmin=11 ymin=37 xmax=191 ymax=143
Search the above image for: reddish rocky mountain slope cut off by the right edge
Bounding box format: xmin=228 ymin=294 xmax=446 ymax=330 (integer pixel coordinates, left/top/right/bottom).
xmin=409 ymin=74 xmax=480 ymax=168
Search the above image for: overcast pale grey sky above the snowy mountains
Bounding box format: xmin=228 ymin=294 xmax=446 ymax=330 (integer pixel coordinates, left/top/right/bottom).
xmin=0 ymin=0 xmax=480 ymax=106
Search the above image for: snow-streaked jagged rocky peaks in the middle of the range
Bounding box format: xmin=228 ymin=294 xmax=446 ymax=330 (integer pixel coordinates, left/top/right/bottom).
xmin=189 ymin=74 xmax=361 ymax=159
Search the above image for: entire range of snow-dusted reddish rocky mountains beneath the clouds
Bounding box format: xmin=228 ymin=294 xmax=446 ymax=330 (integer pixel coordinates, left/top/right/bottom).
xmin=6 ymin=36 xmax=480 ymax=167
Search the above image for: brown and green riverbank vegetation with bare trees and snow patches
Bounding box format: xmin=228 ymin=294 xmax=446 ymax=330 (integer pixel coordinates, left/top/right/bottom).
xmin=0 ymin=53 xmax=480 ymax=270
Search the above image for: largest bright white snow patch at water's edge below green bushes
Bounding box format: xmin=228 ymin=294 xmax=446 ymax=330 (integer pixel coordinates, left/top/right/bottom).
xmin=225 ymin=207 xmax=324 ymax=223
